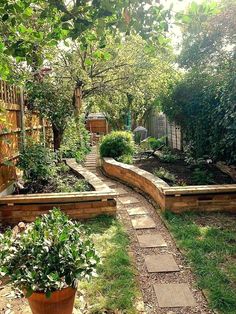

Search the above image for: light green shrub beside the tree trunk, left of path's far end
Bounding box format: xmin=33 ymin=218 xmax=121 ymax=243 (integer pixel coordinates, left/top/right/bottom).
xmin=60 ymin=117 xmax=90 ymax=163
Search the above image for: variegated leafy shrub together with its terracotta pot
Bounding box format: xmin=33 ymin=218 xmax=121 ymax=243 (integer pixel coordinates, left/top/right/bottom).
xmin=0 ymin=208 xmax=99 ymax=314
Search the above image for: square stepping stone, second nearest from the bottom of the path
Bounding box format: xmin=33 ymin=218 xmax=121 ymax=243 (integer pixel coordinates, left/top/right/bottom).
xmin=145 ymin=254 xmax=179 ymax=273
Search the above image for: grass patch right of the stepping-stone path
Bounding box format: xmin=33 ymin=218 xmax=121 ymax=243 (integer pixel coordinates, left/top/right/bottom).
xmin=164 ymin=212 xmax=236 ymax=314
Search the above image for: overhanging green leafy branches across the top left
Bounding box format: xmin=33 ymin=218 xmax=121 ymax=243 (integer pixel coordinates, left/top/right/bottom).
xmin=0 ymin=0 xmax=170 ymax=78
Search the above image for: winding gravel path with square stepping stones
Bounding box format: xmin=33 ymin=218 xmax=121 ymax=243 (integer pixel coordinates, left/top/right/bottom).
xmin=85 ymin=147 xmax=212 ymax=314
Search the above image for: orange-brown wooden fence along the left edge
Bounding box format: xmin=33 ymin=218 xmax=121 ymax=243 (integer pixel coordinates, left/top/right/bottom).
xmin=0 ymin=81 xmax=51 ymax=193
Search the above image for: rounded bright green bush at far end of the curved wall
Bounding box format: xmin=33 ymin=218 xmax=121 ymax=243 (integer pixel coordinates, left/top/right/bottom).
xmin=100 ymin=131 xmax=134 ymax=159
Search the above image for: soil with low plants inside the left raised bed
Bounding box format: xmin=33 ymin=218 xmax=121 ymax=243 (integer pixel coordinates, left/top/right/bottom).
xmin=13 ymin=170 xmax=94 ymax=195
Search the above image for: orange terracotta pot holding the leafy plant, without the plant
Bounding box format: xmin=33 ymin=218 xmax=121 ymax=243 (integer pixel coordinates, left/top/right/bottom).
xmin=28 ymin=287 xmax=76 ymax=314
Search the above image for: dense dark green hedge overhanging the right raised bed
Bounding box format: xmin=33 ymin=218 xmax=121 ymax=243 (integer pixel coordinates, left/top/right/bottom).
xmin=163 ymin=71 xmax=236 ymax=163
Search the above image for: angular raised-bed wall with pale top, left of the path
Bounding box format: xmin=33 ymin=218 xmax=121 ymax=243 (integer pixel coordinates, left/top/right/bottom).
xmin=0 ymin=159 xmax=117 ymax=224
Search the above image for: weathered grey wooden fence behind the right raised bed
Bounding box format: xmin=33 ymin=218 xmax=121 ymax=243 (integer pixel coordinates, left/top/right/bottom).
xmin=145 ymin=110 xmax=183 ymax=150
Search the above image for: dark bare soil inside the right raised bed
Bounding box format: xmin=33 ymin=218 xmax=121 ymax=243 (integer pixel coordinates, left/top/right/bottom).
xmin=135 ymin=152 xmax=235 ymax=186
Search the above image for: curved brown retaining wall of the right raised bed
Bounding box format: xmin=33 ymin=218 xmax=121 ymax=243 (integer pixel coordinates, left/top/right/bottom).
xmin=102 ymin=158 xmax=236 ymax=213
